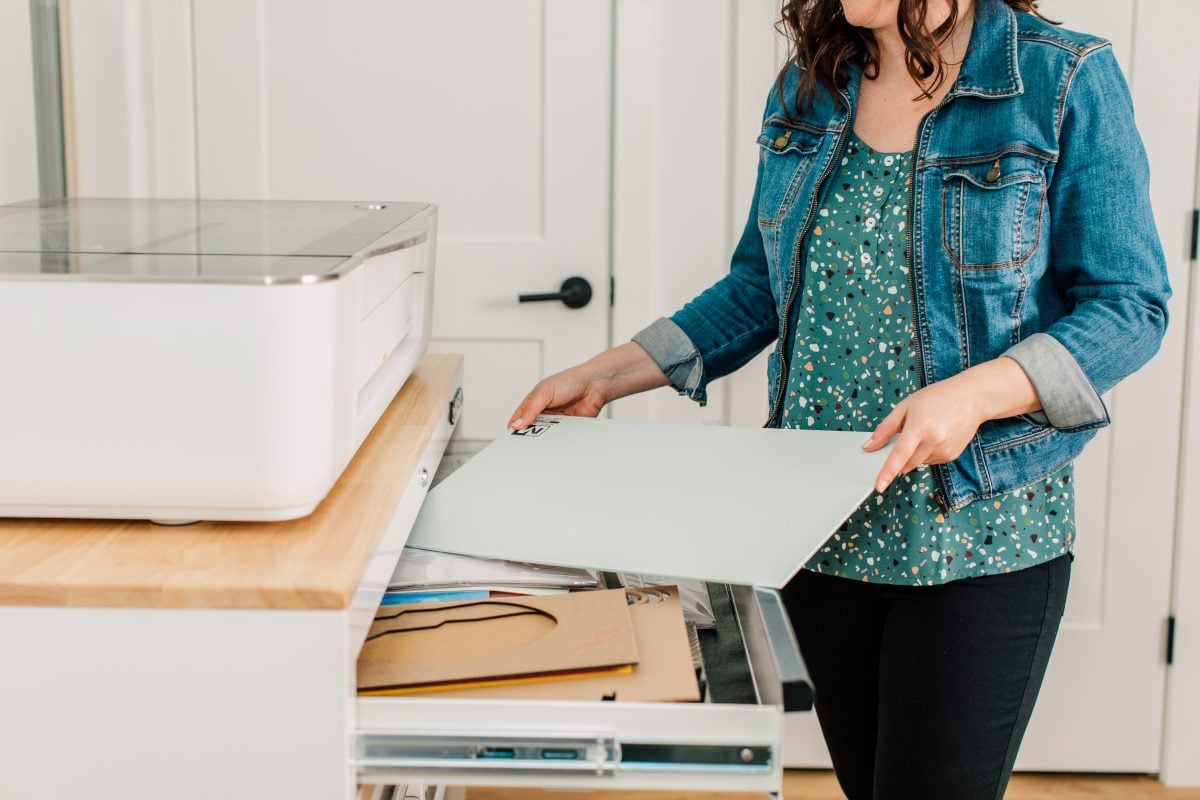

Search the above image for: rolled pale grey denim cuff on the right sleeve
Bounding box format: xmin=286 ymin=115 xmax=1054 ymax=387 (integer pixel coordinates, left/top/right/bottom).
xmin=1003 ymin=333 xmax=1109 ymax=429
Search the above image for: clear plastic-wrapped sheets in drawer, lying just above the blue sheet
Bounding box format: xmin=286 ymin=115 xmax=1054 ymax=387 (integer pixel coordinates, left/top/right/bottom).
xmin=388 ymin=547 xmax=604 ymax=593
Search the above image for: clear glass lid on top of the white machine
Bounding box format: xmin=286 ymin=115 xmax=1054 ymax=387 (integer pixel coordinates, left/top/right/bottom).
xmin=0 ymin=199 xmax=427 ymax=283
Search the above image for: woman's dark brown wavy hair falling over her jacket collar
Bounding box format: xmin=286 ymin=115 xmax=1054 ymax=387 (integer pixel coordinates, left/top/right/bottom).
xmin=775 ymin=0 xmax=1058 ymax=112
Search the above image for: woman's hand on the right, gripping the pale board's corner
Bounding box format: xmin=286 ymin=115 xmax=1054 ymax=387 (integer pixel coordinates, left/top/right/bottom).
xmin=863 ymin=356 xmax=1042 ymax=492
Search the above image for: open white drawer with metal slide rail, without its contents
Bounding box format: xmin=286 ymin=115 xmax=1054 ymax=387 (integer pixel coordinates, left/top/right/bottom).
xmin=354 ymin=584 xmax=812 ymax=793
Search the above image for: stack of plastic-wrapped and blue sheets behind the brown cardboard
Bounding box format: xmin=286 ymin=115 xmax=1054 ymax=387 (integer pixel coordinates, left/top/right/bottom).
xmin=383 ymin=547 xmax=600 ymax=606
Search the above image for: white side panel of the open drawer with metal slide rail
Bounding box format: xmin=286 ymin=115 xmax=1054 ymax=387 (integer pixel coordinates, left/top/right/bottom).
xmin=354 ymin=697 xmax=782 ymax=792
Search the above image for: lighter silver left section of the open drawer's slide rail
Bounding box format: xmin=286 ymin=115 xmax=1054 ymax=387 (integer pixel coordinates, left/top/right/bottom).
xmin=355 ymin=732 xmax=620 ymax=775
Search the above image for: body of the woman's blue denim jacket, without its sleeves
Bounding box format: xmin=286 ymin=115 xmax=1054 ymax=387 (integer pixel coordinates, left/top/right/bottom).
xmin=757 ymin=2 xmax=1123 ymax=507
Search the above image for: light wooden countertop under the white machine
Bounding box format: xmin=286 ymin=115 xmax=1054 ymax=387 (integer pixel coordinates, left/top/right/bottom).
xmin=0 ymin=355 xmax=462 ymax=608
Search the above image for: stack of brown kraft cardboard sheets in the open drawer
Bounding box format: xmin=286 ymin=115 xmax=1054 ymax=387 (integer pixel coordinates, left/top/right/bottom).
xmin=359 ymin=587 xmax=700 ymax=700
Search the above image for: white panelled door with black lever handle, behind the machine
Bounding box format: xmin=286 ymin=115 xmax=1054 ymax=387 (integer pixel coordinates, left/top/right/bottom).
xmin=60 ymin=0 xmax=612 ymax=440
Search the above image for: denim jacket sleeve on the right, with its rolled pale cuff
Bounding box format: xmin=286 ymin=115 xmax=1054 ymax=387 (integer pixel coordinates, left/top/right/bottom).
xmin=1004 ymin=44 xmax=1171 ymax=431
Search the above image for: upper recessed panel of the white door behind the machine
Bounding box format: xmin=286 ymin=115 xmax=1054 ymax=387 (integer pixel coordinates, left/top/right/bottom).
xmin=189 ymin=0 xmax=545 ymax=241
